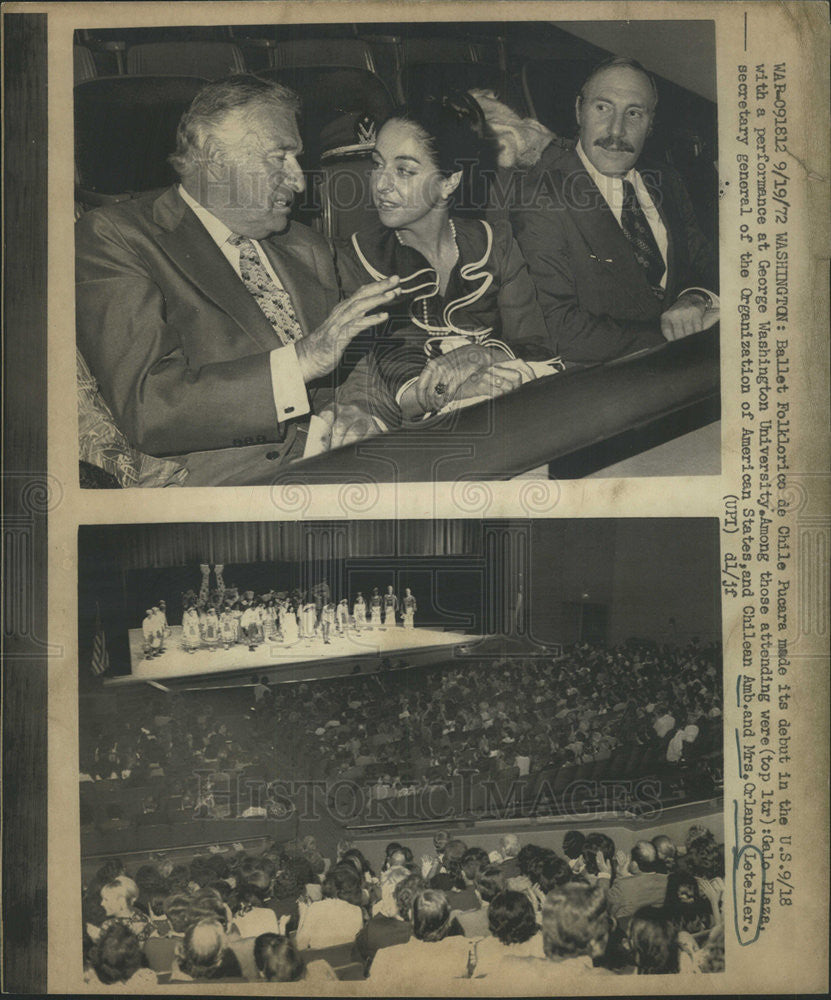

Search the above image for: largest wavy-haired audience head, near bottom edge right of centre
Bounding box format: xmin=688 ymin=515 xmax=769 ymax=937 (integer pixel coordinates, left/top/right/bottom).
xmin=542 ymin=883 xmax=610 ymax=959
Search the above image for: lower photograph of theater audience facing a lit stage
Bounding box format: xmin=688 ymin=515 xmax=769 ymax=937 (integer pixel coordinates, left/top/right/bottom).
xmin=78 ymin=518 xmax=724 ymax=995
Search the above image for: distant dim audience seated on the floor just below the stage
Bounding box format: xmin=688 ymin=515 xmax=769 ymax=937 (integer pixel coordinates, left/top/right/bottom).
xmin=81 ymin=645 xmax=722 ymax=824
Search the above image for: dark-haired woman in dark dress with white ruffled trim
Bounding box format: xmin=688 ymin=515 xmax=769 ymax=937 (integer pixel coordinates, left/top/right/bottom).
xmin=324 ymin=94 xmax=554 ymax=447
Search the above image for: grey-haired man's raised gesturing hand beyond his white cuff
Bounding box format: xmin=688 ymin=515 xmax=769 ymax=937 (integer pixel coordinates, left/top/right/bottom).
xmin=295 ymin=274 xmax=399 ymax=384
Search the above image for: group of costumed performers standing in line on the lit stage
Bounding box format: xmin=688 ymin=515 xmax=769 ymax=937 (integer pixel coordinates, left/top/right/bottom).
xmin=143 ymin=563 xmax=417 ymax=659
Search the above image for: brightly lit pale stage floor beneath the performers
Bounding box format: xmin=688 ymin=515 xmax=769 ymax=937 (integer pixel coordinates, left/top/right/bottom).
xmin=115 ymin=625 xmax=480 ymax=684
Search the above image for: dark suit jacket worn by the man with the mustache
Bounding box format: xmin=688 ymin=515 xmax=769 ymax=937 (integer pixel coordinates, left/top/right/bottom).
xmin=510 ymin=147 xmax=717 ymax=363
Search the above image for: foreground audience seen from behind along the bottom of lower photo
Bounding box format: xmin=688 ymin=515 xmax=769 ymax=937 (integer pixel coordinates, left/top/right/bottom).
xmin=83 ymin=826 xmax=724 ymax=995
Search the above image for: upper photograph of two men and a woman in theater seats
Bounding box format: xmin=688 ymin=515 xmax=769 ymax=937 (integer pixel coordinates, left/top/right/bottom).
xmin=74 ymin=14 xmax=721 ymax=489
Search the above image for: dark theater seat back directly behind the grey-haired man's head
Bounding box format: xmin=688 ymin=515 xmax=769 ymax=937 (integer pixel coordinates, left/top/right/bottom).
xmin=75 ymin=76 xmax=206 ymax=206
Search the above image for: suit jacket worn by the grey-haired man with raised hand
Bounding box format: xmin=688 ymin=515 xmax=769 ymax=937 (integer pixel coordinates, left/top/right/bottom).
xmin=75 ymin=188 xmax=338 ymax=486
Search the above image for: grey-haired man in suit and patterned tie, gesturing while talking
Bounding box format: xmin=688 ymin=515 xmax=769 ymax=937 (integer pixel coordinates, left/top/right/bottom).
xmin=76 ymin=76 xmax=397 ymax=486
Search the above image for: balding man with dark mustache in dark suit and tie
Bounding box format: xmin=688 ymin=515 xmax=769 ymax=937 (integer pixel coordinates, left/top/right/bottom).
xmin=510 ymin=57 xmax=719 ymax=363
